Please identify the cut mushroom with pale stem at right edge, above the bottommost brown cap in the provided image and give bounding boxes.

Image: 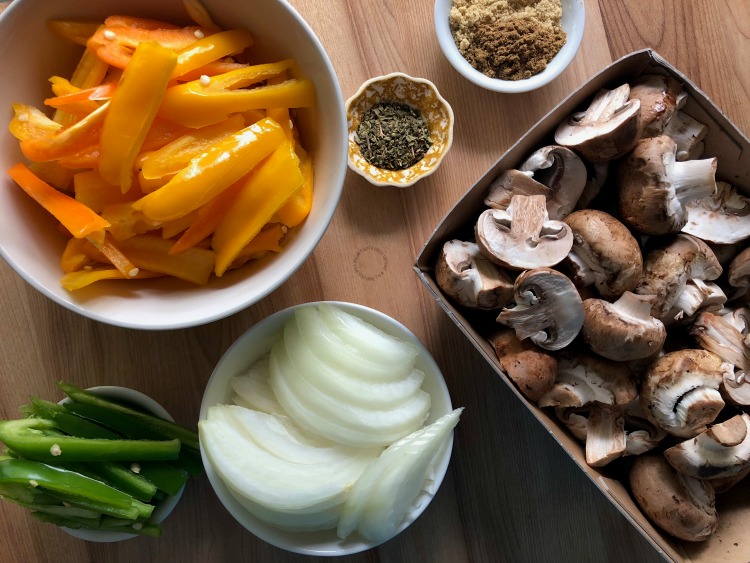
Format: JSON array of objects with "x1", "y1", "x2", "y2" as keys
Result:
[{"x1": 664, "y1": 414, "x2": 750, "y2": 479}]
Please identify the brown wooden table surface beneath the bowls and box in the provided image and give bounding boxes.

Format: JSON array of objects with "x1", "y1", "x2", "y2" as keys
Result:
[{"x1": 0, "y1": 0, "x2": 750, "y2": 563}]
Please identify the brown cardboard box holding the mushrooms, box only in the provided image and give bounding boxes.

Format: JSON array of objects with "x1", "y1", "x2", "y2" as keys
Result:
[{"x1": 415, "y1": 50, "x2": 750, "y2": 563}]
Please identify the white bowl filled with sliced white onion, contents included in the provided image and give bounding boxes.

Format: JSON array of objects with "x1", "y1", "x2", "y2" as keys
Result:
[{"x1": 199, "y1": 302, "x2": 461, "y2": 556}]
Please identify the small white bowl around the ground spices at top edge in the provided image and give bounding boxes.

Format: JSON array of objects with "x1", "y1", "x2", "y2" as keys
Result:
[{"x1": 434, "y1": 0, "x2": 586, "y2": 94}]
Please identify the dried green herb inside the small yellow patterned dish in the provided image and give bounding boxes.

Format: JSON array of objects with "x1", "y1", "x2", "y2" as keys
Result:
[{"x1": 354, "y1": 101, "x2": 432, "y2": 170}]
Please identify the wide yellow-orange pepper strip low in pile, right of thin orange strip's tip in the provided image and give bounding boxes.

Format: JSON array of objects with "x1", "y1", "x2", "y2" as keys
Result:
[{"x1": 118, "y1": 234, "x2": 215, "y2": 285}]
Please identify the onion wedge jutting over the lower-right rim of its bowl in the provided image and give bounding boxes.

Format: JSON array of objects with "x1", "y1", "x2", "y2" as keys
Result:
[{"x1": 337, "y1": 408, "x2": 463, "y2": 542}]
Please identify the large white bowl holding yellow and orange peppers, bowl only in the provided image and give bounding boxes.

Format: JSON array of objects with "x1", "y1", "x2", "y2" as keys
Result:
[{"x1": 0, "y1": 0, "x2": 347, "y2": 329}]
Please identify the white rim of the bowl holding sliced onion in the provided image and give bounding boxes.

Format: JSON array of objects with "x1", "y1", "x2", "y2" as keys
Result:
[{"x1": 199, "y1": 301, "x2": 454, "y2": 556}]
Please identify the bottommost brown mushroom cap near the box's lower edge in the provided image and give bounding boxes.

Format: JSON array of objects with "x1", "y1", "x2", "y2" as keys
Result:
[{"x1": 629, "y1": 454, "x2": 719, "y2": 541}]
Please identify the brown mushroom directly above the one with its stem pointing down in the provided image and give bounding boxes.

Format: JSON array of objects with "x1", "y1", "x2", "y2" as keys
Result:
[{"x1": 537, "y1": 354, "x2": 638, "y2": 408}]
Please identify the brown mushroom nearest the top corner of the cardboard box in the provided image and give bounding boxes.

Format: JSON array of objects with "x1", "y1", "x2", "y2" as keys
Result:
[{"x1": 630, "y1": 74, "x2": 684, "y2": 137}]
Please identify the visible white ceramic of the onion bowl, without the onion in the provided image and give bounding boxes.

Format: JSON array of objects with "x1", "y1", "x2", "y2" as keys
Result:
[{"x1": 200, "y1": 302, "x2": 453, "y2": 556}]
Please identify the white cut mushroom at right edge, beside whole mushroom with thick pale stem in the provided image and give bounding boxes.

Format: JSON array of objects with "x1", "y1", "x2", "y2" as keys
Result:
[{"x1": 681, "y1": 182, "x2": 750, "y2": 244}]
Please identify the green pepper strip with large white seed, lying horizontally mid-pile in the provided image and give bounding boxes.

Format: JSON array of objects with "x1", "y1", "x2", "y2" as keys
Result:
[{"x1": 0, "y1": 418, "x2": 180, "y2": 462}]
